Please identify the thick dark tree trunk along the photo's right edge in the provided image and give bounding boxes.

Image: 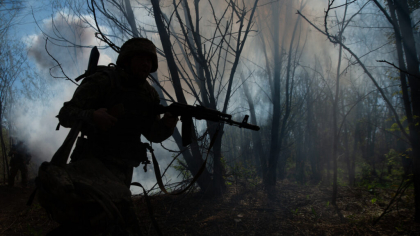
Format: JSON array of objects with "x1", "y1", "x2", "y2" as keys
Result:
[{"x1": 374, "y1": 0, "x2": 420, "y2": 222}]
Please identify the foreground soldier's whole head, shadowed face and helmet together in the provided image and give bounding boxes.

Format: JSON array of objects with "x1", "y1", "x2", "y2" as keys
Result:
[{"x1": 117, "y1": 38, "x2": 158, "y2": 81}]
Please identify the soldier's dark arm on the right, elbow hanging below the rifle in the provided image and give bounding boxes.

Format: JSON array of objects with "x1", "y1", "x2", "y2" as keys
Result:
[{"x1": 143, "y1": 88, "x2": 177, "y2": 143}]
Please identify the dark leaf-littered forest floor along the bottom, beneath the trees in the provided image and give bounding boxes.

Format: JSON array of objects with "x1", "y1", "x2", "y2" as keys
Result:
[{"x1": 0, "y1": 181, "x2": 420, "y2": 236}]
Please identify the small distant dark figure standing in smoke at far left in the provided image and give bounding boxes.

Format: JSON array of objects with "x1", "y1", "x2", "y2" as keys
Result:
[{"x1": 9, "y1": 141, "x2": 31, "y2": 187}]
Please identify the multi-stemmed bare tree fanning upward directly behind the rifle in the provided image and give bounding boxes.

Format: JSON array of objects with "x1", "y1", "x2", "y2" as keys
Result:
[{"x1": 152, "y1": 1, "x2": 258, "y2": 195}]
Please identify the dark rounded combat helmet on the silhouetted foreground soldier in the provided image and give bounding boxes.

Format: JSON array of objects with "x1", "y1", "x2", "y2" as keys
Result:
[{"x1": 117, "y1": 38, "x2": 158, "y2": 72}]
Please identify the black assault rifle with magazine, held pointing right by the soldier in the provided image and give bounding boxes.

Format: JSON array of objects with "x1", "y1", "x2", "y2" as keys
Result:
[{"x1": 155, "y1": 102, "x2": 260, "y2": 147}]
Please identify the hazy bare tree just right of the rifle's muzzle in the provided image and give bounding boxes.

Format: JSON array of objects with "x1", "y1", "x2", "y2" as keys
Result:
[{"x1": 254, "y1": 1, "x2": 305, "y2": 191}]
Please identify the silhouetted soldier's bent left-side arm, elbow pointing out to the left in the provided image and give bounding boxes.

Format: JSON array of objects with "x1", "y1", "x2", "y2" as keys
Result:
[{"x1": 57, "y1": 73, "x2": 111, "y2": 128}]
